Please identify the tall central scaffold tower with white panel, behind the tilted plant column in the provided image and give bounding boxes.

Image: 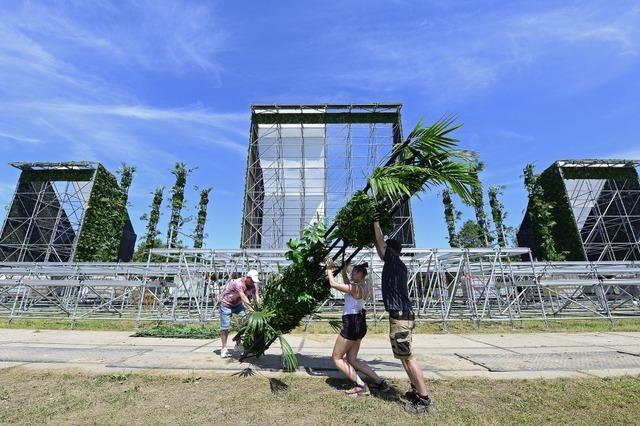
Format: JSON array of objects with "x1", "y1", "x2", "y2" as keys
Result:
[{"x1": 241, "y1": 104, "x2": 415, "y2": 249}]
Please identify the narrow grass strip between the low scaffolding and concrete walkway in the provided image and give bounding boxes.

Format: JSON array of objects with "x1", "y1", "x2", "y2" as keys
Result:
[{"x1": 0, "y1": 317, "x2": 640, "y2": 334}]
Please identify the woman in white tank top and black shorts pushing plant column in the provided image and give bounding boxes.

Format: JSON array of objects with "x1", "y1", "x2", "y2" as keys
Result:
[{"x1": 327, "y1": 259, "x2": 389, "y2": 396}]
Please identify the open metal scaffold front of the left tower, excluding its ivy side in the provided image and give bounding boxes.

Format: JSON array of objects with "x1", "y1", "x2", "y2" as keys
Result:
[{"x1": 0, "y1": 161, "x2": 98, "y2": 262}]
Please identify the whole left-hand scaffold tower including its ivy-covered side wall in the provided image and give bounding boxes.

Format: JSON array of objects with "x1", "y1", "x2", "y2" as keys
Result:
[{"x1": 0, "y1": 162, "x2": 136, "y2": 262}]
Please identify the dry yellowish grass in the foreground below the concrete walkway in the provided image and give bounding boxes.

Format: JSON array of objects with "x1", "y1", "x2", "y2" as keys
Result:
[{"x1": 0, "y1": 368, "x2": 640, "y2": 425}]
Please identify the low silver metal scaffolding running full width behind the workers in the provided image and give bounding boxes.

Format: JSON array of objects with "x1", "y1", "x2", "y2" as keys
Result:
[{"x1": 0, "y1": 248, "x2": 640, "y2": 327}]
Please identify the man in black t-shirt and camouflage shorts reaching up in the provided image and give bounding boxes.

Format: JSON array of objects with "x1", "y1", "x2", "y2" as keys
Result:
[{"x1": 373, "y1": 218, "x2": 431, "y2": 414}]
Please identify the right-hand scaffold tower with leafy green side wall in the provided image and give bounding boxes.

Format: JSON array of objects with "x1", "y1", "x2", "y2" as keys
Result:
[{"x1": 518, "y1": 160, "x2": 640, "y2": 261}]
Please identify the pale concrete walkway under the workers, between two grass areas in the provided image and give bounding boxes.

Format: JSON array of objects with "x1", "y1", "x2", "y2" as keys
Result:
[{"x1": 0, "y1": 329, "x2": 640, "y2": 379}]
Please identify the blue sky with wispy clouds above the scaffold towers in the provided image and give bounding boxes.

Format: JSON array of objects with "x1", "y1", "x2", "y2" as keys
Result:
[{"x1": 0, "y1": 0, "x2": 640, "y2": 248}]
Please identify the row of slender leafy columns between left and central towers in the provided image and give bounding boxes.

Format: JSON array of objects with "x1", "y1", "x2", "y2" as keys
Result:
[{"x1": 118, "y1": 163, "x2": 212, "y2": 262}]
